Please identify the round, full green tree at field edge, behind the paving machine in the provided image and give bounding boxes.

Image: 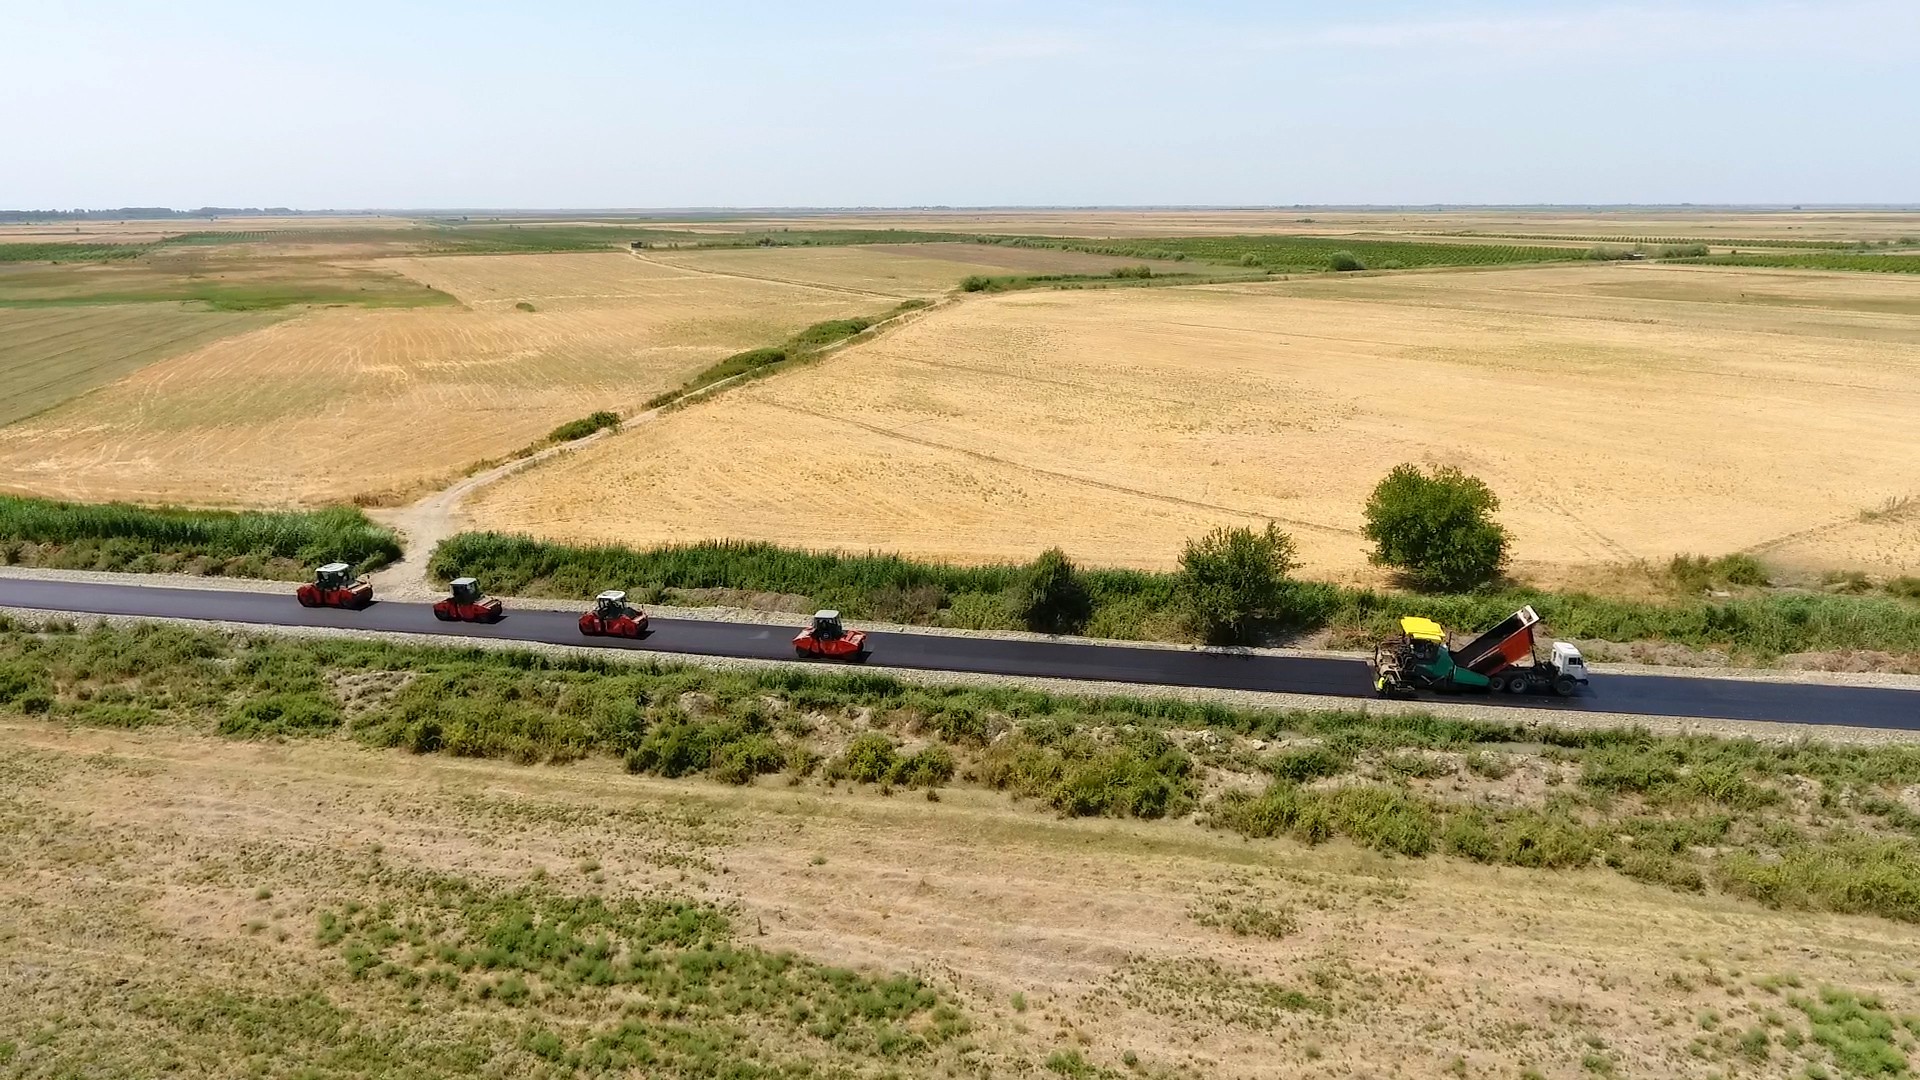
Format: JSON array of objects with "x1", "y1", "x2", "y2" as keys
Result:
[{"x1": 1361, "y1": 465, "x2": 1507, "y2": 590}]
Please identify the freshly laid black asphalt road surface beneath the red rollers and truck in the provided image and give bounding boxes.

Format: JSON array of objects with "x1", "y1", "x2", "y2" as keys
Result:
[{"x1": 0, "y1": 578, "x2": 1920, "y2": 730}]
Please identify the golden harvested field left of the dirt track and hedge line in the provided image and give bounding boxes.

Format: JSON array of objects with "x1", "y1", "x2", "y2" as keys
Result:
[{"x1": 0, "y1": 254, "x2": 889, "y2": 505}]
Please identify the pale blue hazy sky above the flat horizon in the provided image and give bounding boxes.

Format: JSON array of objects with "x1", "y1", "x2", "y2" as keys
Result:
[{"x1": 0, "y1": 0, "x2": 1920, "y2": 209}]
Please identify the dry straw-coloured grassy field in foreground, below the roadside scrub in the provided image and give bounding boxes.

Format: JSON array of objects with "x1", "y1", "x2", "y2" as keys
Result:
[{"x1": 11, "y1": 714, "x2": 1920, "y2": 1080}]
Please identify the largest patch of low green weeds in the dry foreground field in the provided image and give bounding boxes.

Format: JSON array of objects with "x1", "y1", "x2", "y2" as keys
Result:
[{"x1": 317, "y1": 876, "x2": 970, "y2": 1076}]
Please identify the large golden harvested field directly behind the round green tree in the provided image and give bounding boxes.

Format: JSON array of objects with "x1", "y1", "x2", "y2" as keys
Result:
[{"x1": 470, "y1": 263, "x2": 1920, "y2": 578}]
